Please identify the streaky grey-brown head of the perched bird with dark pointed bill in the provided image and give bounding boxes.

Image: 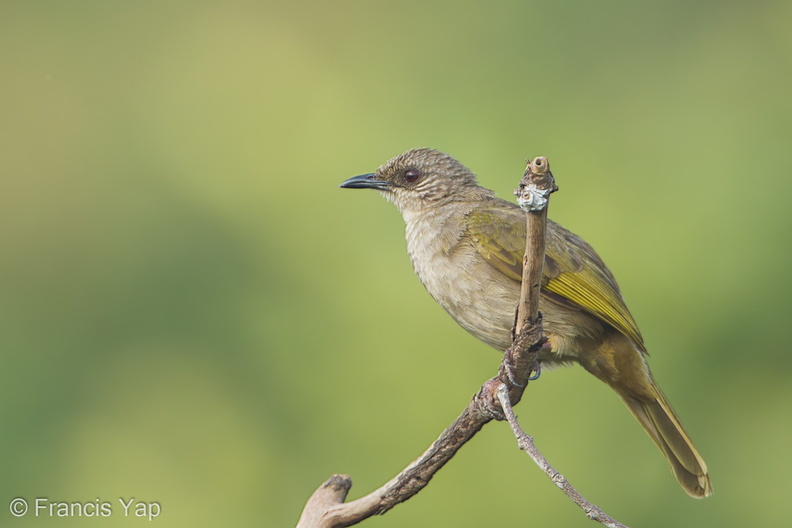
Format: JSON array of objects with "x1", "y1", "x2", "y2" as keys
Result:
[{"x1": 341, "y1": 148, "x2": 492, "y2": 214}]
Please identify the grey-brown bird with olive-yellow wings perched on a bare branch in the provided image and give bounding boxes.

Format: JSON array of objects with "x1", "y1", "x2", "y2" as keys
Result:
[{"x1": 341, "y1": 148, "x2": 713, "y2": 498}]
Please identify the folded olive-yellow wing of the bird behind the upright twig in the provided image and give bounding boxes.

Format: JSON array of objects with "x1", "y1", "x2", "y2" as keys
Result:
[{"x1": 466, "y1": 207, "x2": 644, "y2": 349}]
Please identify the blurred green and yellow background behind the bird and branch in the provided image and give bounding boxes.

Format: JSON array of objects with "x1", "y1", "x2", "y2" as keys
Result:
[{"x1": 0, "y1": 0, "x2": 792, "y2": 528}]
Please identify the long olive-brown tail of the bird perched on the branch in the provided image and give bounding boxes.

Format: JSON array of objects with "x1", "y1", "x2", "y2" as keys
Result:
[{"x1": 617, "y1": 382, "x2": 712, "y2": 499}]
